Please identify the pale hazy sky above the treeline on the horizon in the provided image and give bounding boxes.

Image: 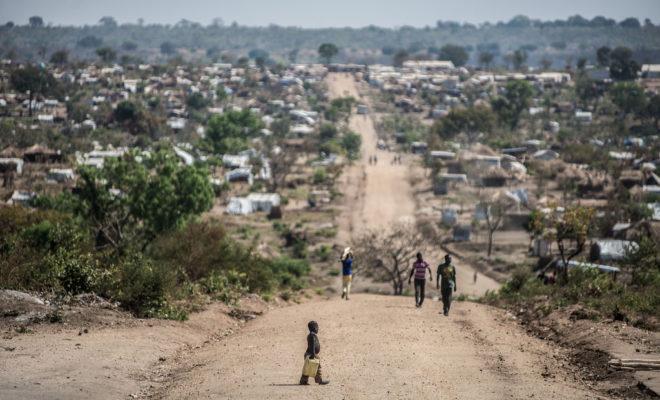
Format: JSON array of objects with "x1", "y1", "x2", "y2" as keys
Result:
[{"x1": 0, "y1": 0, "x2": 660, "y2": 27}]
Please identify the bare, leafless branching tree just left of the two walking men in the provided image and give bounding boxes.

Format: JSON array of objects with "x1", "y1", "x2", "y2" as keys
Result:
[{"x1": 355, "y1": 223, "x2": 429, "y2": 295}]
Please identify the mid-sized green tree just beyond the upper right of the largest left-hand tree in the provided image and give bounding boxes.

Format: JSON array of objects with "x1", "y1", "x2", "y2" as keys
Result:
[{"x1": 206, "y1": 110, "x2": 263, "y2": 154}]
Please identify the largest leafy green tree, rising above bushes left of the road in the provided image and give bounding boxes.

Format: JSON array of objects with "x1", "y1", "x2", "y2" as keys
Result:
[{"x1": 75, "y1": 150, "x2": 213, "y2": 250}]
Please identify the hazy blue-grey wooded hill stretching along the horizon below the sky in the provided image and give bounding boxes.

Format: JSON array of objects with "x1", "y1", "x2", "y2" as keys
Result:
[{"x1": 0, "y1": 16, "x2": 660, "y2": 67}]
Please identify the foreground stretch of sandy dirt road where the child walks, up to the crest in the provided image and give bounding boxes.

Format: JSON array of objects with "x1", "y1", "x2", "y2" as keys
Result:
[{"x1": 164, "y1": 295, "x2": 600, "y2": 400}]
